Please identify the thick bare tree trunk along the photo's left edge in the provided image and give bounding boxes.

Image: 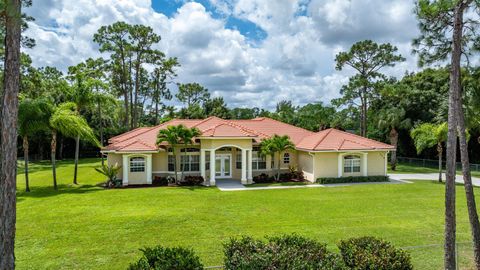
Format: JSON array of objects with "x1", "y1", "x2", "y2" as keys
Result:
[{"x1": 0, "y1": 0, "x2": 21, "y2": 270}]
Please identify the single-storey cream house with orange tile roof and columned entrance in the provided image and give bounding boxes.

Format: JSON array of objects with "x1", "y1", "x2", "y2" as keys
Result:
[{"x1": 102, "y1": 117, "x2": 394, "y2": 185}]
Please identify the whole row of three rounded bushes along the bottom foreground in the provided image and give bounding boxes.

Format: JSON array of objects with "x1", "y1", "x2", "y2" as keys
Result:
[{"x1": 129, "y1": 234, "x2": 413, "y2": 270}]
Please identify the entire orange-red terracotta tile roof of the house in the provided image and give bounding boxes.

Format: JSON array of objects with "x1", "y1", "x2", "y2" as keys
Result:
[{"x1": 102, "y1": 117, "x2": 394, "y2": 152}]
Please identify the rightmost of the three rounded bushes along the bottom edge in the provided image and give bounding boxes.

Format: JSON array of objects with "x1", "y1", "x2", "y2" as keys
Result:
[{"x1": 338, "y1": 237, "x2": 413, "y2": 270}]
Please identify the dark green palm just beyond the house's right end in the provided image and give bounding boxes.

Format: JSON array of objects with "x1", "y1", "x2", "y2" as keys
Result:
[{"x1": 378, "y1": 107, "x2": 412, "y2": 171}]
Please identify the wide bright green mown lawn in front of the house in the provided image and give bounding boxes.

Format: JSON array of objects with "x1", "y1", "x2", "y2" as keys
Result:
[{"x1": 16, "y1": 160, "x2": 480, "y2": 269}]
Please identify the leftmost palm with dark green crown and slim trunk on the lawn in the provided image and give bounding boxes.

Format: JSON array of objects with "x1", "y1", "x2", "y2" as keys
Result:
[{"x1": 18, "y1": 98, "x2": 49, "y2": 192}]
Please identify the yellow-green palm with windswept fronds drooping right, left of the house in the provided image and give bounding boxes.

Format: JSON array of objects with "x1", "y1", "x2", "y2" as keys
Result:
[{"x1": 49, "y1": 102, "x2": 100, "y2": 189}]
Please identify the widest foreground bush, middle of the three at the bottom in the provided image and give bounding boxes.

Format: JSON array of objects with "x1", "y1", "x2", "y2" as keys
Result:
[{"x1": 224, "y1": 235, "x2": 346, "y2": 270}]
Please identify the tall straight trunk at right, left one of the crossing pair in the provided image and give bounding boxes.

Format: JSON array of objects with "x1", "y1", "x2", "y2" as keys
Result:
[{"x1": 444, "y1": 4, "x2": 463, "y2": 270}]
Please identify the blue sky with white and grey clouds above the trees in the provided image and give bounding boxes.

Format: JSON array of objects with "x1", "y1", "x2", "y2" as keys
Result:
[{"x1": 26, "y1": 0, "x2": 418, "y2": 109}]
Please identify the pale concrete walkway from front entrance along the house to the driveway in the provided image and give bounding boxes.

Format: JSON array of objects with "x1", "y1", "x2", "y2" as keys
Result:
[{"x1": 216, "y1": 179, "x2": 411, "y2": 191}]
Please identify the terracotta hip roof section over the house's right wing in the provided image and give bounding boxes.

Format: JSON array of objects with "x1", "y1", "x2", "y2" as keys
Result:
[{"x1": 296, "y1": 128, "x2": 395, "y2": 151}]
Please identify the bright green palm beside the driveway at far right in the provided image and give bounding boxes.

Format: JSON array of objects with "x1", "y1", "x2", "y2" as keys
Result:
[{"x1": 410, "y1": 123, "x2": 448, "y2": 182}]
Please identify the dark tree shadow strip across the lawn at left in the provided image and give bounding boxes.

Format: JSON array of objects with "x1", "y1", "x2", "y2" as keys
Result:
[{"x1": 17, "y1": 184, "x2": 105, "y2": 201}]
